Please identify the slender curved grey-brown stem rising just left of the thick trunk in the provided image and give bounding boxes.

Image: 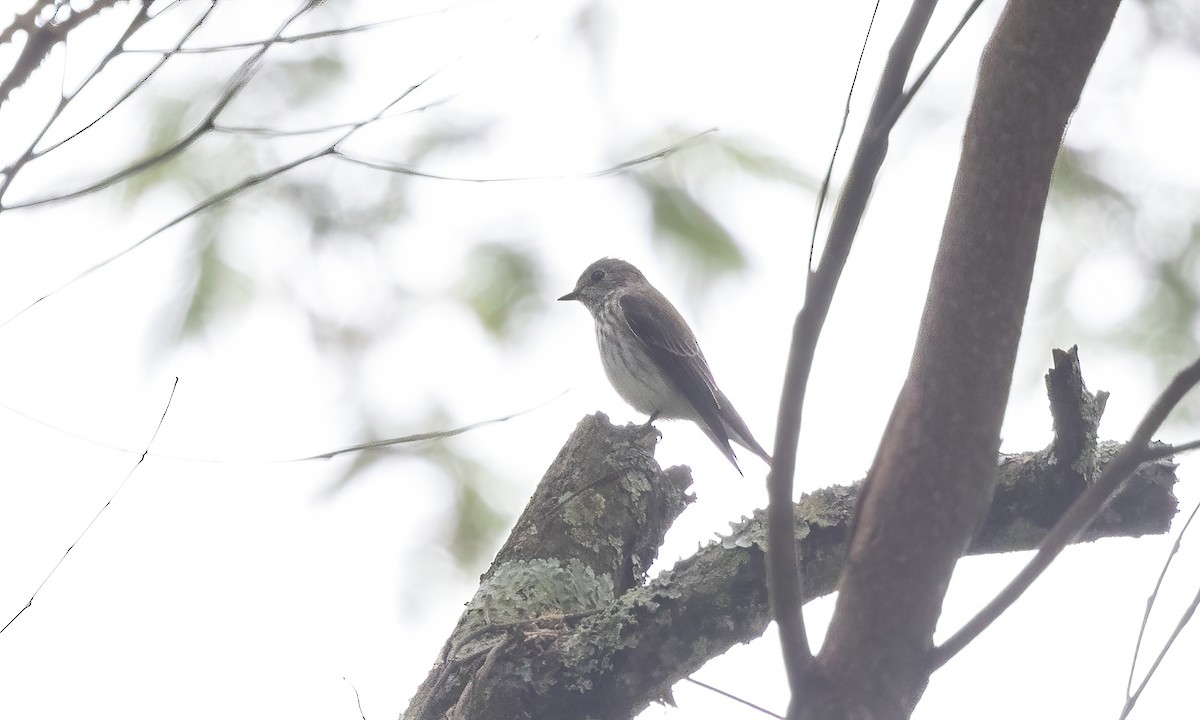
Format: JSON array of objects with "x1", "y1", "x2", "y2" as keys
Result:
[{"x1": 767, "y1": 0, "x2": 936, "y2": 700}]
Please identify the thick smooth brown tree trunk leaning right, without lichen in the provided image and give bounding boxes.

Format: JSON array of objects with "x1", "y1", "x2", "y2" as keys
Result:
[{"x1": 816, "y1": 0, "x2": 1117, "y2": 719}]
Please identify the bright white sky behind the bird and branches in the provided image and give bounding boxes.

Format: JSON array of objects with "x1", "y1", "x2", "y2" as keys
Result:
[{"x1": 0, "y1": 0, "x2": 1200, "y2": 720}]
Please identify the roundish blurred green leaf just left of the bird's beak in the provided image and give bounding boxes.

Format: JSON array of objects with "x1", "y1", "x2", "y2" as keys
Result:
[{"x1": 458, "y1": 242, "x2": 541, "y2": 338}]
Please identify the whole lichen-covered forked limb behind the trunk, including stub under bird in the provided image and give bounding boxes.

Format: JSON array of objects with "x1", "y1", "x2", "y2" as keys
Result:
[{"x1": 404, "y1": 352, "x2": 1176, "y2": 719}]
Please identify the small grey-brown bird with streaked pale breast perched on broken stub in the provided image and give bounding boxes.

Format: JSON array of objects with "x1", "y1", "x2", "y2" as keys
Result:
[{"x1": 559, "y1": 258, "x2": 770, "y2": 474}]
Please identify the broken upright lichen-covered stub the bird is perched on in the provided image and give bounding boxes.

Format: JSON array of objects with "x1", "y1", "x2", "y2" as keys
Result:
[{"x1": 404, "y1": 414, "x2": 692, "y2": 719}]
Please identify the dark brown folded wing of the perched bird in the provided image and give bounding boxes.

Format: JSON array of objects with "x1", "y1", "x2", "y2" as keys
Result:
[{"x1": 619, "y1": 293, "x2": 737, "y2": 467}]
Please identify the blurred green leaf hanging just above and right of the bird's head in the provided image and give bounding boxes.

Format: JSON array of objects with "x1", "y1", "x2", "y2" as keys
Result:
[{"x1": 638, "y1": 176, "x2": 745, "y2": 274}]
